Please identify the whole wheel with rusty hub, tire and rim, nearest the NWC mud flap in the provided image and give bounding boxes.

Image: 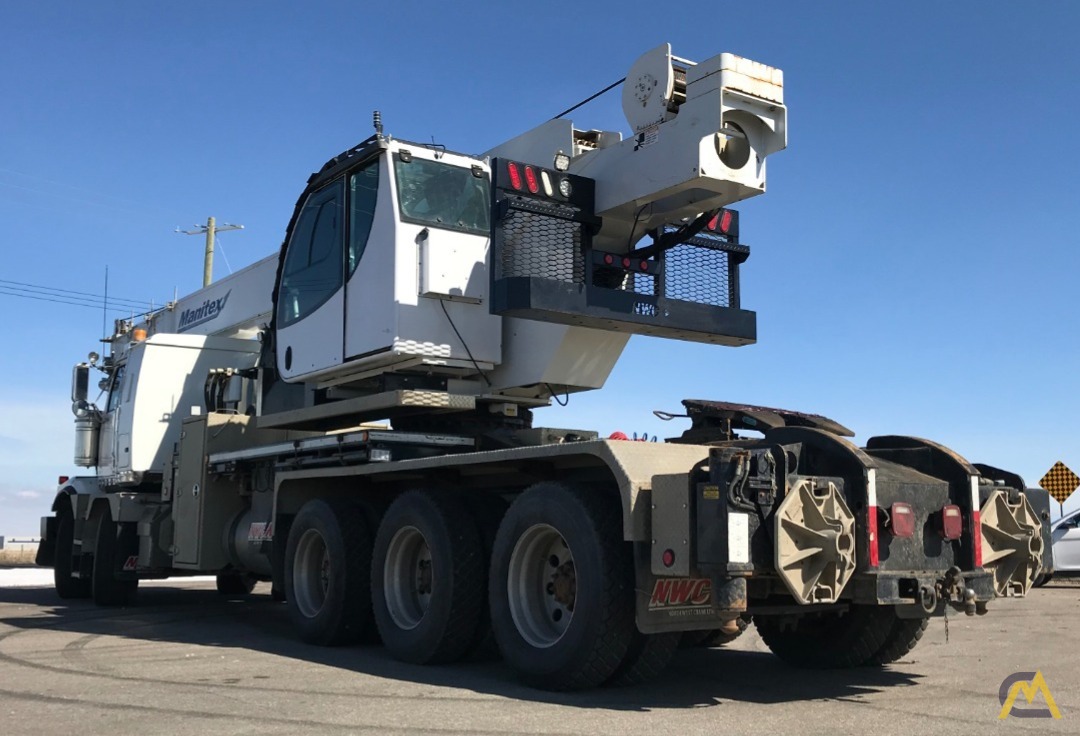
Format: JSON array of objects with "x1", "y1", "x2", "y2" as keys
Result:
[{"x1": 490, "y1": 482, "x2": 635, "y2": 691}]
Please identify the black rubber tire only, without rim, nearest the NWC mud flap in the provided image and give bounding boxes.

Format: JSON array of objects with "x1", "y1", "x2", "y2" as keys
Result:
[{"x1": 489, "y1": 482, "x2": 636, "y2": 691}]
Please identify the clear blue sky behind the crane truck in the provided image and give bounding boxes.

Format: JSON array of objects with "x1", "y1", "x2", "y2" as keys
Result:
[{"x1": 0, "y1": 1, "x2": 1080, "y2": 534}]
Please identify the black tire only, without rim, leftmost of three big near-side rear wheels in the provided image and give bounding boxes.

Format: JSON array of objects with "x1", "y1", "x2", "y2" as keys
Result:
[{"x1": 284, "y1": 498, "x2": 372, "y2": 646}]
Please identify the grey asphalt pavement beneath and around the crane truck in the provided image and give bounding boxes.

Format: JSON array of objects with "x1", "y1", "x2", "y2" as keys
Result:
[{"x1": 0, "y1": 571, "x2": 1080, "y2": 736}]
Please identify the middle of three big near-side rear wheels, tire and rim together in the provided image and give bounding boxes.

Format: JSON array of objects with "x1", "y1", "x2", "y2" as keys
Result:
[{"x1": 372, "y1": 491, "x2": 487, "y2": 665}]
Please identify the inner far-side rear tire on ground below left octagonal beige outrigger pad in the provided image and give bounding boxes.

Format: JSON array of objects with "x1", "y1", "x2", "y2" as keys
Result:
[{"x1": 754, "y1": 605, "x2": 896, "y2": 669}]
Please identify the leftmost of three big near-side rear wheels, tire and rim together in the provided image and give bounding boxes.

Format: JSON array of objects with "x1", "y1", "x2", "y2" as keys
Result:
[{"x1": 285, "y1": 498, "x2": 372, "y2": 646}]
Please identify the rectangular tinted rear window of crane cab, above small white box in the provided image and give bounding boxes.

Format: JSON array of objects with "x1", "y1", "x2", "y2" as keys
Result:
[{"x1": 394, "y1": 155, "x2": 490, "y2": 236}]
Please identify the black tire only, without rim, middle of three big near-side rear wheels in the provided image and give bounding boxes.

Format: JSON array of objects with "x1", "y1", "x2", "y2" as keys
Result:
[{"x1": 372, "y1": 491, "x2": 487, "y2": 665}]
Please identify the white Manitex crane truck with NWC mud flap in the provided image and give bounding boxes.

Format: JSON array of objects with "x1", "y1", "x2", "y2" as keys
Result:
[{"x1": 31, "y1": 44, "x2": 1045, "y2": 690}]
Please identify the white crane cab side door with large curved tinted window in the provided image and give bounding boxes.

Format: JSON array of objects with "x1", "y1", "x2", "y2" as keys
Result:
[{"x1": 276, "y1": 179, "x2": 345, "y2": 380}]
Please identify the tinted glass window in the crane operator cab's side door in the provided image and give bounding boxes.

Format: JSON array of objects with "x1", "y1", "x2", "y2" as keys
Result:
[{"x1": 278, "y1": 179, "x2": 345, "y2": 326}]
